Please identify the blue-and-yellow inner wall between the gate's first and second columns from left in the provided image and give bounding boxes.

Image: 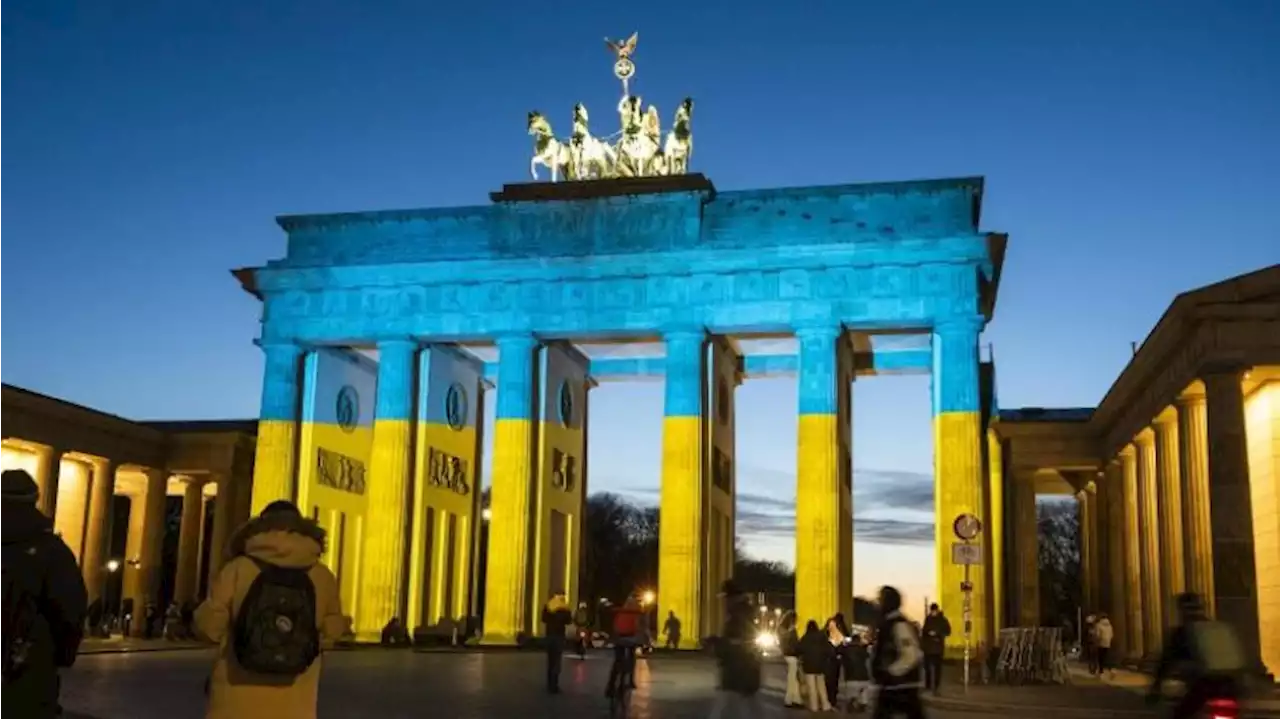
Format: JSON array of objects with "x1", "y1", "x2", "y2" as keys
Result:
[{"x1": 297, "y1": 348, "x2": 378, "y2": 617}]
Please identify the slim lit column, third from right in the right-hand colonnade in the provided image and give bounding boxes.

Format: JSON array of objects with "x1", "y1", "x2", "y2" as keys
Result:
[{"x1": 1155, "y1": 411, "x2": 1187, "y2": 636}]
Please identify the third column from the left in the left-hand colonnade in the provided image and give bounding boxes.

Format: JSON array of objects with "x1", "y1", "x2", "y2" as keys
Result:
[{"x1": 125, "y1": 468, "x2": 169, "y2": 636}]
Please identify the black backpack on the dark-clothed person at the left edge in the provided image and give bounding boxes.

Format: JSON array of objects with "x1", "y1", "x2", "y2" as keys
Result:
[{"x1": 0, "y1": 542, "x2": 42, "y2": 687}]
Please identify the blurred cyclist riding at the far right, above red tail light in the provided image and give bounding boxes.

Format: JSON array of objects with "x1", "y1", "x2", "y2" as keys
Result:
[{"x1": 1147, "y1": 592, "x2": 1248, "y2": 719}]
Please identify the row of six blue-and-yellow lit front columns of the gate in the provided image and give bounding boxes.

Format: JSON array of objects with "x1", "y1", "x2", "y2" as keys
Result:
[{"x1": 252, "y1": 317, "x2": 992, "y2": 646}]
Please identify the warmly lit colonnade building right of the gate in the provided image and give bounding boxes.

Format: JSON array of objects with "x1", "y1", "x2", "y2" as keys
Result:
[{"x1": 989, "y1": 265, "x2": 1280, "y2": 672}]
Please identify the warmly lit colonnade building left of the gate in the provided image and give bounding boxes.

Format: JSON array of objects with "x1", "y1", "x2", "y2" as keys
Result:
[{"x1": 0, "y1": 384, "x2": 257, "y2": 628}]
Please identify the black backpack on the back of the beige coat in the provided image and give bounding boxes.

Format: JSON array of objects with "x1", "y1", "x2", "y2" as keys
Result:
[{"x1": 233, "y1": 558, "x2": 320, "y2": 677}]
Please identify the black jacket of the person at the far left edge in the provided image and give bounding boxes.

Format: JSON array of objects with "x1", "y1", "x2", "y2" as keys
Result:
[{"x1": 0, "y1": 500, "x2": 88, "y2": 719}]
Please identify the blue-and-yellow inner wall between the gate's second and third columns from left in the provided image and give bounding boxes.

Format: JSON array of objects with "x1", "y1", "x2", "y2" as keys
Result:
[{"x1": 408, "y1": 345, "x2": 484, "y2": 627}]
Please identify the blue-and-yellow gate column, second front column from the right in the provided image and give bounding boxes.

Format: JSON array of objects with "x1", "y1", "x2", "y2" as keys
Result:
[{"x1": 796, "y1": 326, "x2": 852, "y2": 622}]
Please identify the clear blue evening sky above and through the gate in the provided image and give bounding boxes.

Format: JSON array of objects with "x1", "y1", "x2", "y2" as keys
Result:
[{"x1": 0, "y1": 0, "x2": 1280, "y2": 585}]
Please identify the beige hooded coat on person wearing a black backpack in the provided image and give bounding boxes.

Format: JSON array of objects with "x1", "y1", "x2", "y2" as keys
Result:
[{"x1": 196, "y1": 517, "x2": 348, "y2": 719}]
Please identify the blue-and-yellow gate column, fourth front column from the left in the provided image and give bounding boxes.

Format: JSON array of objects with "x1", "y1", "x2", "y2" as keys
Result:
[{"x1": 658, "y1": 330, "x2": 706, "y2": 649}]
